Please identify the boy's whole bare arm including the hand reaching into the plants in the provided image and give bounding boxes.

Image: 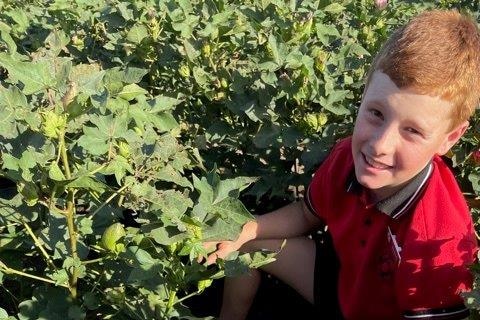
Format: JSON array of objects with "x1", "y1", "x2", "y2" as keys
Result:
[{"x1": 205, "y1": 200, "x2": 322, "y2": 264}]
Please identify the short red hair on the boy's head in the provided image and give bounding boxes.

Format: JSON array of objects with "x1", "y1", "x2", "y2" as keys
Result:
[{"x1": 367, "y1": 10, "x2": 480, "y2": 127}]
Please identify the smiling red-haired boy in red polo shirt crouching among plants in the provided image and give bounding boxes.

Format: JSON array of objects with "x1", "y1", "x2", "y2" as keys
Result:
[{"x1": 202, "y1": 11, "x2": 480, "y2": 320}]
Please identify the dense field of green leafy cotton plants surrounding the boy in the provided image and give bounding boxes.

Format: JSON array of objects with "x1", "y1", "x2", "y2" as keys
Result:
[{"x1": 0, "y1": 0, "x2": 480, "y2": 320}]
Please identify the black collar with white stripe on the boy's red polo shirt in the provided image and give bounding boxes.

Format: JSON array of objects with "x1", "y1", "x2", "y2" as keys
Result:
[{"x1": 346, "y1": 162, "x2": 433, "y2": 219}]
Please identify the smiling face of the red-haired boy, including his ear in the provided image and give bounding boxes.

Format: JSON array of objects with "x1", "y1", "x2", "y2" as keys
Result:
[{"x1": 352, "y1": 71, "x2": 468, "y2": 200}]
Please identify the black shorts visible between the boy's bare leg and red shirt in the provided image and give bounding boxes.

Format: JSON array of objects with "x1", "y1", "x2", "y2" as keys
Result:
[{"x1": 313, "y1": 231, "x2": 343, "y2": 320}]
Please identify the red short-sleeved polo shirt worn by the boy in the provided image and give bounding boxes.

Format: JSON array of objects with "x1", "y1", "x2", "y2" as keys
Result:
[{"x1": 306, "y1": 138, "x2": 477, "y2": 320}]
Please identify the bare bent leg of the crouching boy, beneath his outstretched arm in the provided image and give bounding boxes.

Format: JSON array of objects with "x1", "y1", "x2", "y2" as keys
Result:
[{"x1": 220, "y1": 237, "x2": 315, "y2": 320}]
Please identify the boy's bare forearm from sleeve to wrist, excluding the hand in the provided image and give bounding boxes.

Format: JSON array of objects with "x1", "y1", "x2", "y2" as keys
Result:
[{"x1": 239, "y1": 201, "x2": 321, "y2": 242}]
